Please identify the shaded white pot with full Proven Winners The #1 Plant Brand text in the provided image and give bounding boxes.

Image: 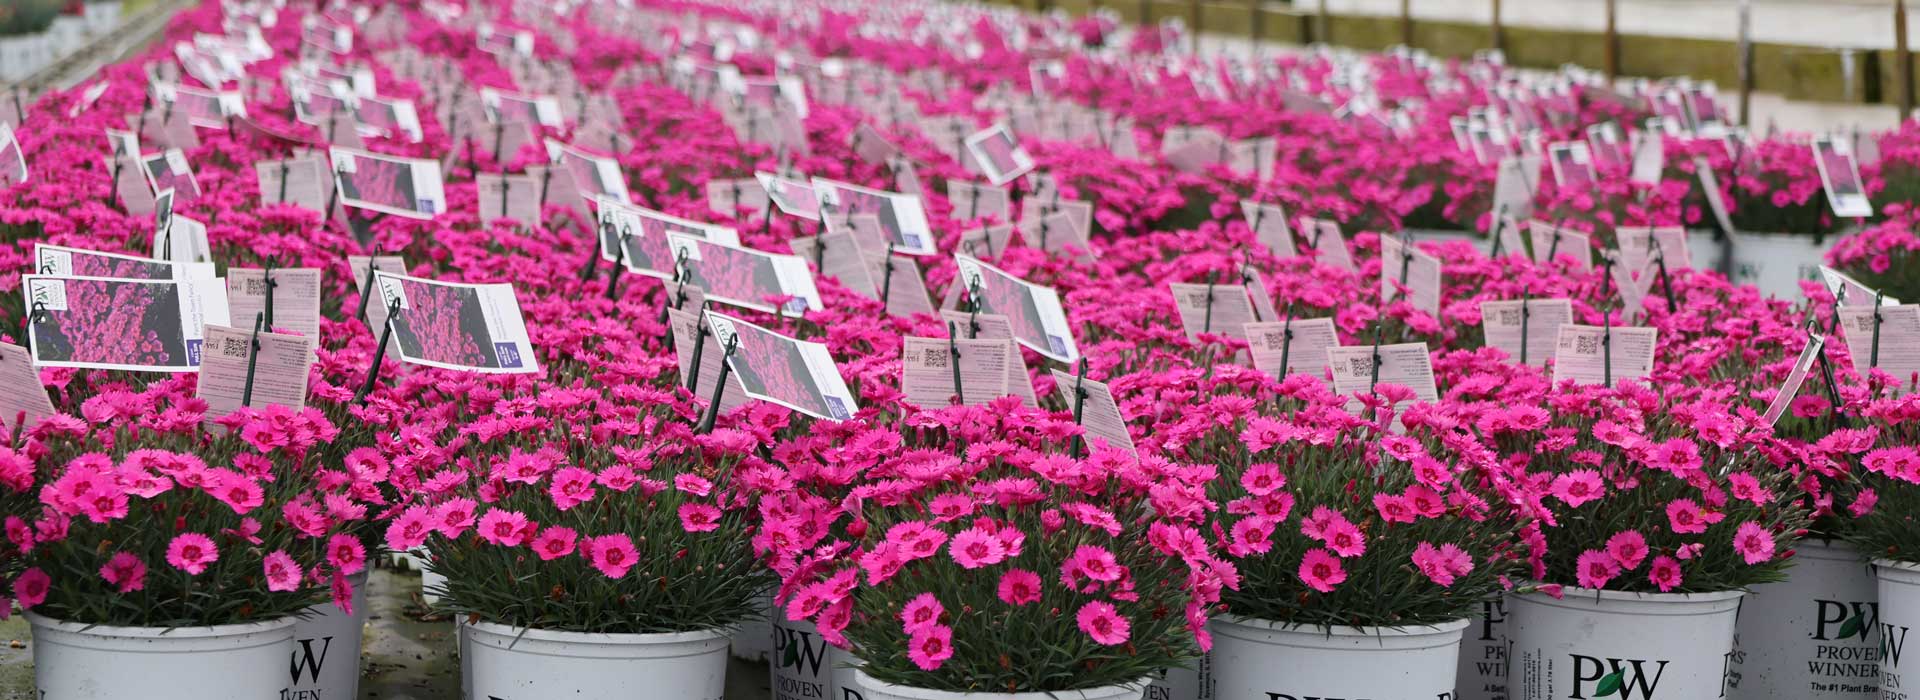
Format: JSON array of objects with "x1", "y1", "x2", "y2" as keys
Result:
[{"x1": 1726, "y1": 539, "x2": 1880, "y2": 700}]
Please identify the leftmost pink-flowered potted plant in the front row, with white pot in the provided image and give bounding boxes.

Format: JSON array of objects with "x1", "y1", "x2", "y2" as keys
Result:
[{"x1": 19, "y1": 393, "x2": 367, "y2": 700}]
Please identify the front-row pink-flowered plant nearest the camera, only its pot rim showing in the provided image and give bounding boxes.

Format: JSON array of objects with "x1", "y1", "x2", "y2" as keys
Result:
[{"x1": 764, "y1": 399, "x2": 1235, "y2": 700}]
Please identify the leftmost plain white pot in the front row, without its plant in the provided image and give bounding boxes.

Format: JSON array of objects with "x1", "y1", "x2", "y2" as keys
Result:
[{"x1": 27, "y1": 612, "x2": 294, "y2": 700}]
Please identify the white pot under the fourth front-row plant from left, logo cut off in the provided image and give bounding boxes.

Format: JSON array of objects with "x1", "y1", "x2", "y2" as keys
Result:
[{"x1": 1210, "y1": 616, "x2": 1467, "y2": 700}]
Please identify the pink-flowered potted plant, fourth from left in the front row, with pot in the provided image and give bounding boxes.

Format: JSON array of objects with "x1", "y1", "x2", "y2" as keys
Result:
[{"x1": 1183, "y1": 376, "x2": 1524, "y2": 698}]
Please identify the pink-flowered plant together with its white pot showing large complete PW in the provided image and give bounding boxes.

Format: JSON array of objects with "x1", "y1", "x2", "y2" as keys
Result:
[{"x1": 1490, "y1": 384, "x2": 1809, "y2": 700}]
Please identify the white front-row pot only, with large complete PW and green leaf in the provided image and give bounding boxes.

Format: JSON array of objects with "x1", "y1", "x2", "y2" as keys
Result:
[{"x1": 1507, "y1": 587, "x2": 1743, "y2": 700}]
